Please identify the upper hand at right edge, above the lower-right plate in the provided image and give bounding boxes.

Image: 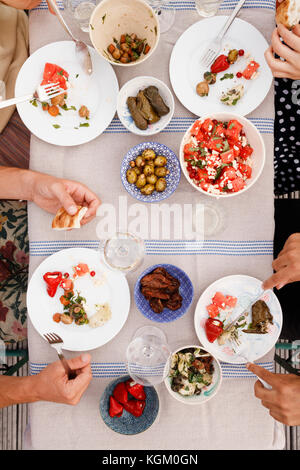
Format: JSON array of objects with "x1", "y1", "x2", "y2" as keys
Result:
[{"x1": 263, "y1": 233, "x2": 300, "y2": 290}]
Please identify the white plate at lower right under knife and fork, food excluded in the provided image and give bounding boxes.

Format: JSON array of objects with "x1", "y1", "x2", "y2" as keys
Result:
[{"x1": 194, "y1": 274, "x2": 282, "y2": 364}]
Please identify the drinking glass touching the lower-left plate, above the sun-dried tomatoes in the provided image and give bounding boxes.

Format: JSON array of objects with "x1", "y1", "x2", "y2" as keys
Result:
[{"x1": 102, "y1": 232, "x2": 145, "y2": 273}]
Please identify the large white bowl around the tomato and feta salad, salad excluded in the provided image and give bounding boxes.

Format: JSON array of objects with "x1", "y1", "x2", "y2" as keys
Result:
[{"x1": 179, "y1": 113, "x2": 266, "y2": 199}]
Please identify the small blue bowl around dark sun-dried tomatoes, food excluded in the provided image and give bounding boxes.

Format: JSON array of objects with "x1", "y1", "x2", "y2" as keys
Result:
[{"x1": 134, "y1": 264, "x2": 194, "y2": 323}]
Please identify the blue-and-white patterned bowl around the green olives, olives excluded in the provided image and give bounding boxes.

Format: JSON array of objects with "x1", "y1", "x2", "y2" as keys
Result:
[{"x1": 121, "y1": 142, "x2": 181, "y2": 202}]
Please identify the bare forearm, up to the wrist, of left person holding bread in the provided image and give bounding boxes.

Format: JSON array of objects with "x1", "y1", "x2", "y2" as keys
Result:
[{"x1": 0, "y1": 166, "x2": 36, "y2": 201}]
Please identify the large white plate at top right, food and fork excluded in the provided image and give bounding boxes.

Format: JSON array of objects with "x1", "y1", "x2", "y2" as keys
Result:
[{"x1": 170, "y1": 16, "x2": 273, "y2": 116}]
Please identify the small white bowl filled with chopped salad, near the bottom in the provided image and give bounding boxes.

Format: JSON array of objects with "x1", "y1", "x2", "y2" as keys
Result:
[{"x1": 165, "y1": 345, "x2": 222, "y2": 405}]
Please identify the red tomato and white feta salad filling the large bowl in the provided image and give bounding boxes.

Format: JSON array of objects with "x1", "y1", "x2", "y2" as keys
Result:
[{"x1": 183, "y1": 118, "x2": 253, "y2": 195}]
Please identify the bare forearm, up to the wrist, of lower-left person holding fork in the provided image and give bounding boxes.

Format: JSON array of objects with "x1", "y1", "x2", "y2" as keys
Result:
[{"x1": 0, "y1": 375, "x2": 38, "y2": 408}]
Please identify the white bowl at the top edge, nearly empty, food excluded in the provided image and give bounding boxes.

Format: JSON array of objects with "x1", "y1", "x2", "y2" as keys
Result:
[{"x1": 89, "y1": 0, "x2": 160, "y2": 67}]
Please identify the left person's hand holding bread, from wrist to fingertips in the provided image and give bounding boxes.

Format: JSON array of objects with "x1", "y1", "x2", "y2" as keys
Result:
[{"x1": 30, "y1": 172, "x2": 100, "y2": 225}]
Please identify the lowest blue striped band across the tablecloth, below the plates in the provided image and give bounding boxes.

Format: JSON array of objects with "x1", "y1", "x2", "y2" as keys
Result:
[{"x1": 29, "y1": 362, "x2": 274, "y2": 379}]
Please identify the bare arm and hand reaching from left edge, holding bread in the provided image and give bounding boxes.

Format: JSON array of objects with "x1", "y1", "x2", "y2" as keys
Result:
[{"x1": 0, "y1": 167, "x2": 100, "y2": 225}]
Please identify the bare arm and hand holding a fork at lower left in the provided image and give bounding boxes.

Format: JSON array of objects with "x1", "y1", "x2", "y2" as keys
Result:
[{"x1": 0, "y1": 354, "x2": 92, "y2": 408}]
